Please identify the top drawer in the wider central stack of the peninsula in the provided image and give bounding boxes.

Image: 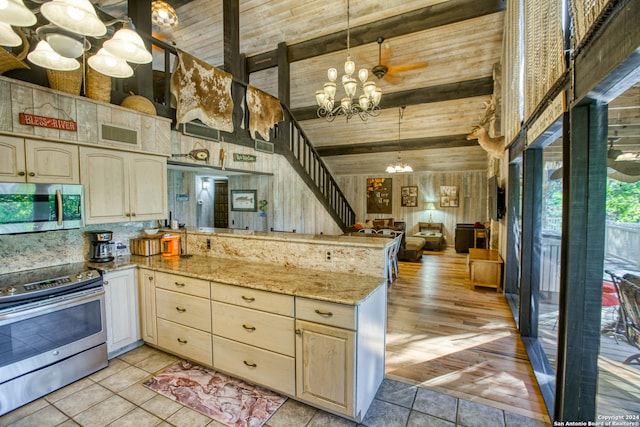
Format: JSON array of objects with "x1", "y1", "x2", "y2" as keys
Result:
[{"x1": 211, "y1": 282, "x2": 293, "y2": 317}]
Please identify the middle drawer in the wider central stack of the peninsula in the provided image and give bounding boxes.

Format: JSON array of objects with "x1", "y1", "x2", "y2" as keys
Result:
[{"x1": 211, "y1": 301, "x2": 295, "y2": 356}]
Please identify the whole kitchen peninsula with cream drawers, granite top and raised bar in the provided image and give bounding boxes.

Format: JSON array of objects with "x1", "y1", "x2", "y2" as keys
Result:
[{"x1": 96, "y1": 229, "x2": 391, "y2": 421}]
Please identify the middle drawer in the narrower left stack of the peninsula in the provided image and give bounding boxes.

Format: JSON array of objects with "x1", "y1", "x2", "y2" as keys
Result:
[{"x1": 156, "y1": 289, "x2": 211, "y2": 332}]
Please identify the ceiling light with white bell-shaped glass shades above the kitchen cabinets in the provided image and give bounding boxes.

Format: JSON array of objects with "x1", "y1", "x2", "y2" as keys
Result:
[{"x1": 0, "y1": 0, "x2": 160, "y2": 78}]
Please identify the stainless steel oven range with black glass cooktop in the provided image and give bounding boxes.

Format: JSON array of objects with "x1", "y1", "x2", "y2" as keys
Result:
[{"x1": 0, "y1": 263, "x2": 107, "y2": 415}]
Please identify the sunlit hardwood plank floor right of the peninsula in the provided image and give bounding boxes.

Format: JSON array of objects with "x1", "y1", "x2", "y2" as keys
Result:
[{"x1": 386, "y1": 248, "x2": 550, "y2": 422}]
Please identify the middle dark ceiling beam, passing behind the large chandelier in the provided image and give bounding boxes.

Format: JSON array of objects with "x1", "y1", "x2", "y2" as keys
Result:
[{"x1": 291, "y1": 77, "x2": 493, "y2": 121}]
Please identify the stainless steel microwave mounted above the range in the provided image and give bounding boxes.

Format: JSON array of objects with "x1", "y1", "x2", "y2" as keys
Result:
[{"x1": 0, "y1": 182, "x2": 84, "y2": 234}]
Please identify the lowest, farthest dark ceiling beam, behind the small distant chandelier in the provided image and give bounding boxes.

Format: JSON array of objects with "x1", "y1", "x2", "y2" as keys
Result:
[{"x1": 315, "y1": 135, "x2": 478, "y2": 157}]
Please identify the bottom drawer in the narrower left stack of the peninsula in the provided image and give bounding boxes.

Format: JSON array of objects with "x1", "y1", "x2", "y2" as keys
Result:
[{"x1": 158, "y1": 319, "x2": 212, "y2": 366}]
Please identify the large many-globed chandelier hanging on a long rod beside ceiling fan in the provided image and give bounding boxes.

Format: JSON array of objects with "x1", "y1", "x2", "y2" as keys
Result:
[{"x1": 316, "y1": 0, "x2": 382, "y2": 122}]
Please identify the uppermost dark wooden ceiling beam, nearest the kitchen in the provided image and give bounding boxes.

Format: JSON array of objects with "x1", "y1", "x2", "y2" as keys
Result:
[{"x1": 247, "y1": 0, "x2": 506, "y2": 73}]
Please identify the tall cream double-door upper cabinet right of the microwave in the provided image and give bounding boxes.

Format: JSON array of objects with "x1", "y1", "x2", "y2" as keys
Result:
[{"x1": 80, "y1": 147, "x2": 167, "y2": 224}]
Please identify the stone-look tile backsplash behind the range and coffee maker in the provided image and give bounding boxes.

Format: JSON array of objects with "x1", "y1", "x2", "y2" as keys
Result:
[{"x1": 0, "y1": 222, "x2": 150, "y2": 274}]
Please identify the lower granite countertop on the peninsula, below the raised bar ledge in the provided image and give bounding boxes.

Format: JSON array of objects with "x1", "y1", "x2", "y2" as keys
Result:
[{"x1": 90, "y1": 255, "x2": 386, "y2": 305}]
